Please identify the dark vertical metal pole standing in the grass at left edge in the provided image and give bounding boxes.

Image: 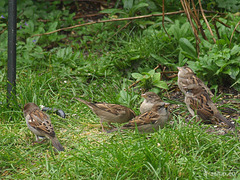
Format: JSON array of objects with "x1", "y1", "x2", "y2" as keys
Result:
[{"x1": 7, "y1": 0, "x2": 17, "y2": 104}]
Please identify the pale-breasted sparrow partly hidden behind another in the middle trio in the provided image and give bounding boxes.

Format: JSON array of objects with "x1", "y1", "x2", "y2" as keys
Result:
[{"x1": 140, "y1": 92, "x2": 162, "y2": 114}]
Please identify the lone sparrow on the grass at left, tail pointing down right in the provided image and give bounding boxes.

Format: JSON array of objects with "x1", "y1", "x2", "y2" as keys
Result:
[{"x1": 23, "y1": 103, "x2": 64, "y2": 151}]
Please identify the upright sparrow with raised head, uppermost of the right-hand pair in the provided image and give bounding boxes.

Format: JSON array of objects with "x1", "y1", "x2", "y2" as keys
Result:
[{"x1": 177, "y1": 66, "x2": 214, "y2": 97}]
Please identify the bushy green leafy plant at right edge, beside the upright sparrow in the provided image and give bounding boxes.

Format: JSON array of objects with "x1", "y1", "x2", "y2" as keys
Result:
[{"x1": 188, "y1": 44, "x2": 240, "y2": 90}]
